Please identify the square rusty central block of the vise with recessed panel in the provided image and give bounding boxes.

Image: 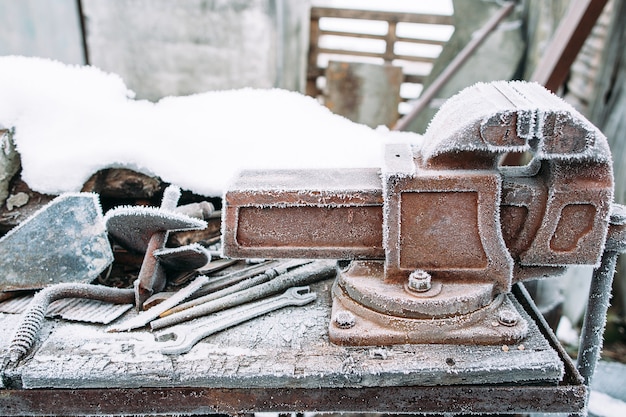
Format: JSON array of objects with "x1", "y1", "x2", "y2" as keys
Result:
[{"x1": 384, "y1": 153, "x2": 513, "y2": 292}]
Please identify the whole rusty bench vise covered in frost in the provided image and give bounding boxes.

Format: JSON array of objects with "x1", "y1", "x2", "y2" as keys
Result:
[{"x1": 223, "y1": 82, "x2": 613, "y2": 345}]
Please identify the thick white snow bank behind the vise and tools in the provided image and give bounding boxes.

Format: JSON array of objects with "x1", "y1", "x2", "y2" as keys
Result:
[{"x1": 0, "y1": 56, "x2": 419, "y2": 196}]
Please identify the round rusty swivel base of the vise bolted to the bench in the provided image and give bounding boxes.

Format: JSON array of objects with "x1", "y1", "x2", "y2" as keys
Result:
[{"x1": 329, "y1": 261, "x2": 529, "y2": 345}]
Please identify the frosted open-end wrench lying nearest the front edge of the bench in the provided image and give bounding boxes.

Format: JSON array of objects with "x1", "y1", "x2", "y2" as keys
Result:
[{"x1": 156, "y1": 286, "x2": 317, "y2": 355}]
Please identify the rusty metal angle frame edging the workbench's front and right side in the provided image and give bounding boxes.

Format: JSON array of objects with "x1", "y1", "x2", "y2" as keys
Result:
[{"x1": 0, "y1": 286, "x2": 586, "y2": 416}]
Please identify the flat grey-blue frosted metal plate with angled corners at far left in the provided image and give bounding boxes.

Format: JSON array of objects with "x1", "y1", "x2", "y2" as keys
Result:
[{"x1": 0, "y1": 193, "x2": 113, "y2": 291}]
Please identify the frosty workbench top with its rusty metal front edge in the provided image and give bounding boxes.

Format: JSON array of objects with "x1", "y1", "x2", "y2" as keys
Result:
[{"x1": 0, "y1": 280, "x2": 586, "y2": 416}]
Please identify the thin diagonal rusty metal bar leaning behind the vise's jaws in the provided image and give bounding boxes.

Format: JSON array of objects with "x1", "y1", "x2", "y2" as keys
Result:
[{"x1": 393, "y1": 1, "x2": 515, "y2": 130}]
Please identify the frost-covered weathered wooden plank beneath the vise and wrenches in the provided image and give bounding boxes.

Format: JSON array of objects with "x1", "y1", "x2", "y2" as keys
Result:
[{"x1": 6, "y1": 281, "x2": 563, "y2": 389}]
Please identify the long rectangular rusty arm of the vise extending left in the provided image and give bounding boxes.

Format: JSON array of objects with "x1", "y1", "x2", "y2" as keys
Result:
[{"x1": 223, "y1": 169, "x2": 384, "y2": 259}]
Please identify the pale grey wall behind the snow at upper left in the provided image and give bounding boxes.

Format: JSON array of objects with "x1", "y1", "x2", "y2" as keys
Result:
[{"x1": 0, "y1": 0, "x2": 310, "y2": 100}]
